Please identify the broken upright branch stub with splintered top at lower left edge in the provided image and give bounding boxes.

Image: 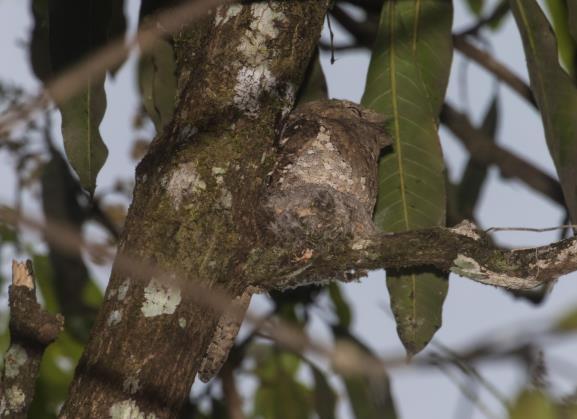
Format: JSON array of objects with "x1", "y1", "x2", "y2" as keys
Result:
[{"x1": 0, "y1": 261, "x2": 64, "y2": 419}]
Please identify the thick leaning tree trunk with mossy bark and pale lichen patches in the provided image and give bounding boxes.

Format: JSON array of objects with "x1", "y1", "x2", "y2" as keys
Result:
[{"x1": 61, "y1": 0, "x2": 327, "y2": 418}]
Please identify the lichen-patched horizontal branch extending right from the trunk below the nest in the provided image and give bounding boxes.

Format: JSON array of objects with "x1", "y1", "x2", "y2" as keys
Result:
[{"x1": 272, "y1": 221, "x2": 577, "y2": 290}]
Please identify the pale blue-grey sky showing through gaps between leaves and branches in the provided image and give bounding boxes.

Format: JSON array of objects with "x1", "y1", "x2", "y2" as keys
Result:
[{"x1": 0, "y1": 0, "x2": 577, "y2": 419}]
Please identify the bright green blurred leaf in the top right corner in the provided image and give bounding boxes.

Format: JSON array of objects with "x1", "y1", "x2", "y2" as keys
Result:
[{"x1": 546, "y1": 0, "x2": 577, "y2": 75}]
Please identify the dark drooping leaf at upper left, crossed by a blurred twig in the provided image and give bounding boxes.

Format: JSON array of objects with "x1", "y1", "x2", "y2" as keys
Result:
[{"x1": 49, "y1": 0, "x2": 126, "y2": 194}]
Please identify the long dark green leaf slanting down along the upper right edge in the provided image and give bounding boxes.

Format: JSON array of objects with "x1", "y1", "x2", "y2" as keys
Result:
[{"x1": 511, "y1": 0, "x2": 577, "y2": 223}]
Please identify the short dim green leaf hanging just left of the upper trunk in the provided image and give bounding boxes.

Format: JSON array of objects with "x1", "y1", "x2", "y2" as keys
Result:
[{"x1": 138, "y1": 39, "x2": 176, "y2": 133}]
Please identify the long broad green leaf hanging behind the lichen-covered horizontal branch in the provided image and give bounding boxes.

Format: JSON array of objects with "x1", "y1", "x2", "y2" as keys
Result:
[{"x1": 363, "y1": 0, "x2": 452, "y2": 355}]
